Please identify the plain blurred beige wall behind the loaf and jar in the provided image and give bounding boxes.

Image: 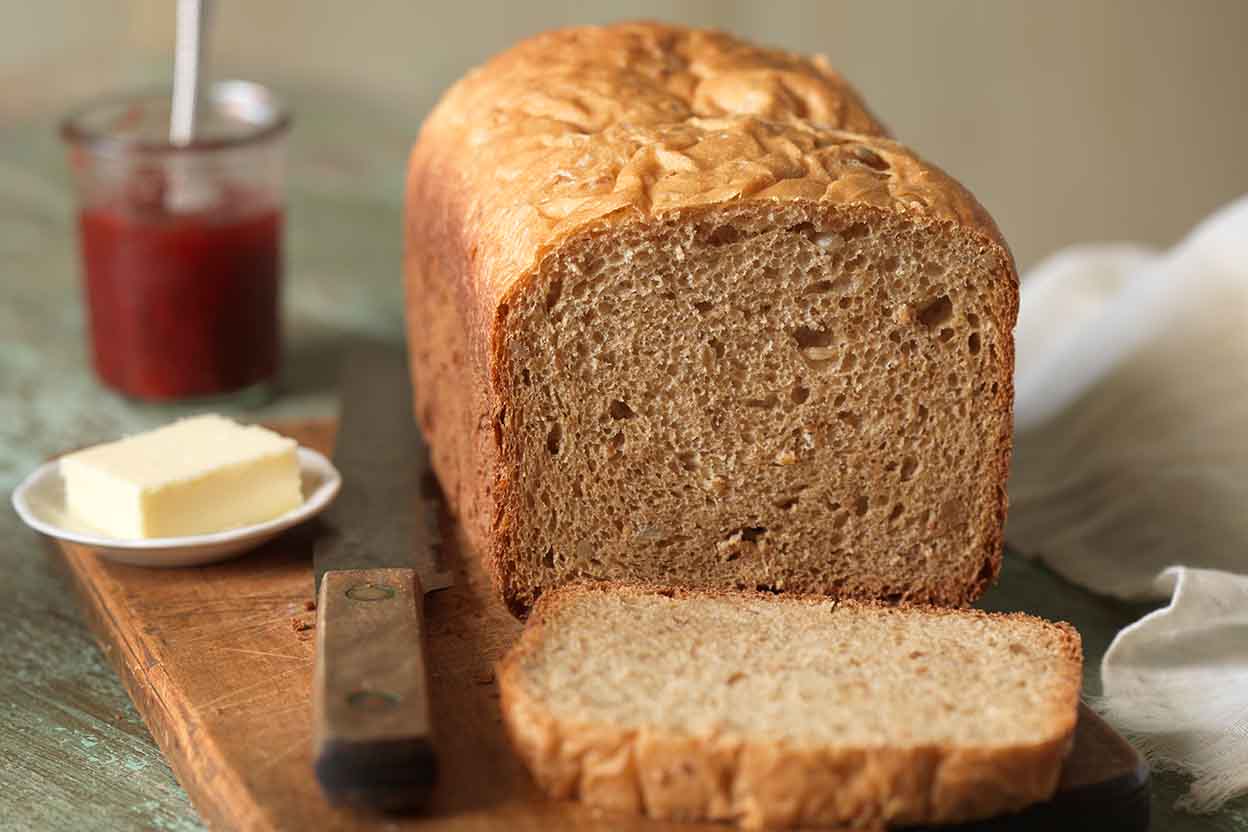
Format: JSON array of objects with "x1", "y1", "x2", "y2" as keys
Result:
[{"x1": 0, "y1": 0, "x2": 1248, "y2": 266}]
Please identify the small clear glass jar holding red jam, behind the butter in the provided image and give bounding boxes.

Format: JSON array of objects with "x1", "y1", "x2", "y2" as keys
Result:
[{"x1": 61, "y1": 81, "x2": 290, "y2": 402}]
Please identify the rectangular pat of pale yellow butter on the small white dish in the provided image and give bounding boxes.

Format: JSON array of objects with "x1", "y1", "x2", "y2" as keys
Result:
[{"x1": 60, "y1": 415, "x2": 303, "y2": 539}]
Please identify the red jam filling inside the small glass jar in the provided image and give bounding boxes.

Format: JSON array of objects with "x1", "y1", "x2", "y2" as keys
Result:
[{"x1": 79, "y1": 188, "x2": 282, "y2": 400}]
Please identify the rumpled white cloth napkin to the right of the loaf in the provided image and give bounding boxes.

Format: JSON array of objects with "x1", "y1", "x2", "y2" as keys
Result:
[{"x1": 1006, "y1": 197, "x2": 1248, "y2": 811}]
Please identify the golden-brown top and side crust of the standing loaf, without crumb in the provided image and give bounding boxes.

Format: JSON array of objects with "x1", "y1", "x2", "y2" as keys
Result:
[{"x1": 404, "y1": 24, "x2": 1017, "y2": 614}]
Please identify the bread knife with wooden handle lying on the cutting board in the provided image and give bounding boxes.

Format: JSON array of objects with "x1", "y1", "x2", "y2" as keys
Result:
[{"x1": 312, "y1": 346, "x2": 453, "y2": 811}]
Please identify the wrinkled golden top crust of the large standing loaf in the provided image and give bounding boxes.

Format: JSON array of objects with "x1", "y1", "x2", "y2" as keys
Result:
[{"x1": 409, "y1": 22, "x2": 1008, "y2": 321}]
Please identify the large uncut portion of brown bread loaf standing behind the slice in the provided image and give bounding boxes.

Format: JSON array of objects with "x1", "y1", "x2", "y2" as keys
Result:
[{"x1": 404, "y1": 24, "x2": 1017, "y2": 615}]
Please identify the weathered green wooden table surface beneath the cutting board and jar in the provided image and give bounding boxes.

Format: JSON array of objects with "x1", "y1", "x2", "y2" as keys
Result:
[{"x1": 0, "y1": 79, "x2": 1248, "y2": 832}]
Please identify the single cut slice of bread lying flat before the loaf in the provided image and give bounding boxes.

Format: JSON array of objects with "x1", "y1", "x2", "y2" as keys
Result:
[{"x1": 499, "y1": 584, "x2": 1082, "y2": 828}]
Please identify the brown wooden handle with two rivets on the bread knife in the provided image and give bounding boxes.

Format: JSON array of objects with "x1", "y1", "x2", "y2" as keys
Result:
[{"x1": 312, "y1": 569, "x2": 438, "y2": 812}]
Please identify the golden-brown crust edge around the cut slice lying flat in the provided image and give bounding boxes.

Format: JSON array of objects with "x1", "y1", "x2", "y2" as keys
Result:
[{"x1": 498, "y1": 583, "x2": 1083, "y2": 828}]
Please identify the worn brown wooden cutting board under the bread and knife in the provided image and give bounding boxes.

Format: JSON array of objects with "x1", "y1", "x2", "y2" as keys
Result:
[{"x1": 60, "y1": 422, "x2": 1148, "y2": 832}]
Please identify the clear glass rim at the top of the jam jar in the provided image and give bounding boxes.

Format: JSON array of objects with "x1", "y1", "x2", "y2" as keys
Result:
[{"x1": 60, "y1": 80, "x2": 292, "y2": 153}]
